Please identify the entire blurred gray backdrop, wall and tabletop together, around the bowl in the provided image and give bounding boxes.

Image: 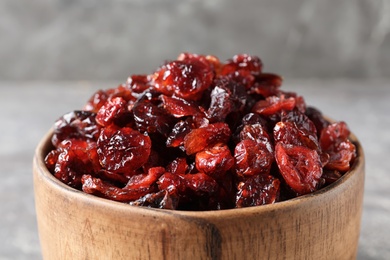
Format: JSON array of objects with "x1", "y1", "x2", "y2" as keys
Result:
[{"x1": 0, "y1": 0, "x2": 390, "y2": 260}]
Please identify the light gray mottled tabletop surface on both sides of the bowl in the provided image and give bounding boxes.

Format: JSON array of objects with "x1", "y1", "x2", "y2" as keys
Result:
[{"x1": 0, "y1": 79, "x2": 390, "y2": 260}]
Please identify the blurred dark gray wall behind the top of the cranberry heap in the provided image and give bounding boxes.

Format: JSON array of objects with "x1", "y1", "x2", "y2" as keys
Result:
[{"x1": 0, "y1": 0, "x2": 390, "y2": 81}]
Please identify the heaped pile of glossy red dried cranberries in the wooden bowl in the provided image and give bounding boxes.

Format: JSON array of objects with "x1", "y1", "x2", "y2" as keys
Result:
[{"x1": 45, "y1": 53, "x2": 356, "y2": 210}]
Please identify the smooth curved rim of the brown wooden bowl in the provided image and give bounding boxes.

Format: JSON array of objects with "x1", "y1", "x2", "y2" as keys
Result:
[{"x1": 33, "y1": 128, "x2": 365, "y2": 218}]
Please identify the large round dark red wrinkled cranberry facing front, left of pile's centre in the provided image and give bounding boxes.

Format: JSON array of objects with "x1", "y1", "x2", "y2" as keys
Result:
[{"x1": 97, "y1": 127, "x2": 152, "y2": 173}]
